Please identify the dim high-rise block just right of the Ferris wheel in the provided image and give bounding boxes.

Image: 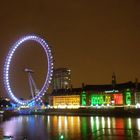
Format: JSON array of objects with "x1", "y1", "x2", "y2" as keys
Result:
[{"x1": 52, "y1": 68, "x2": 71, "y2": 90}]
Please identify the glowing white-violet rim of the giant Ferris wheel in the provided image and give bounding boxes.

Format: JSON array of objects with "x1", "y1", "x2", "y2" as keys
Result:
[{"x1": 4, "y1": 35, "x2": 53, "y2": 105}]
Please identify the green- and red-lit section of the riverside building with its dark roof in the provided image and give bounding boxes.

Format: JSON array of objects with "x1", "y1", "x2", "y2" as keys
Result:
[{"x1": 81, "y1": 82, "x2": 135, "y2": 106}]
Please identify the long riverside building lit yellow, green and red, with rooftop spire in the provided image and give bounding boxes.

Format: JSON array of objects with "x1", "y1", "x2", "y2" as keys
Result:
[{"x1": 50, "y1": 74, "x2": 140, "y2": 108}]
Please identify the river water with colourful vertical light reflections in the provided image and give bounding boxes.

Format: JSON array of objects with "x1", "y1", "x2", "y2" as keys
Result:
[{"x1": 0, "y1": 115, "x2": 140, "y2": 140}]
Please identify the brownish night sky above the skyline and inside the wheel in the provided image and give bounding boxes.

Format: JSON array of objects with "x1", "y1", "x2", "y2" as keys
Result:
[{"x1": 0, "y1": 0, "x2": 140, "y2": 97}]
